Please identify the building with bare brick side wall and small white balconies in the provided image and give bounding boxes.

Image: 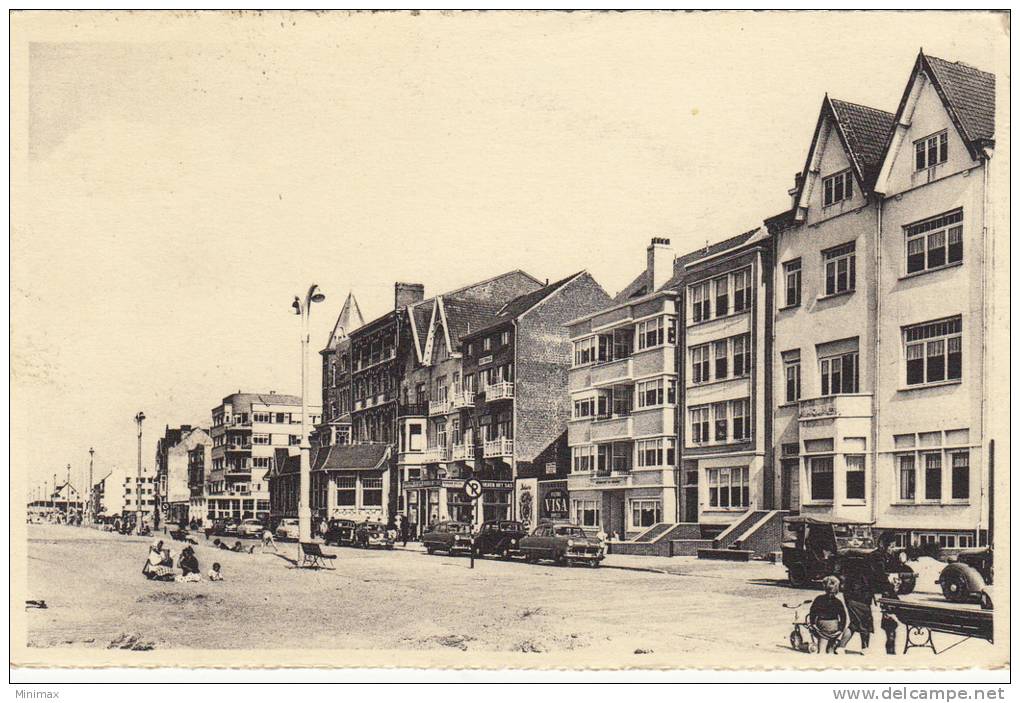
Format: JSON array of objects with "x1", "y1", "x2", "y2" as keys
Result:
[{"x1": 463, "y1": 271, "x2": 611, "y2": 526}]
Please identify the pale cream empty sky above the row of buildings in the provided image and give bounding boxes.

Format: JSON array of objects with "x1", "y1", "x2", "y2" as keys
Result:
[{"x1": 11, "y1": 12, "x2": 1009, "y2": 489}]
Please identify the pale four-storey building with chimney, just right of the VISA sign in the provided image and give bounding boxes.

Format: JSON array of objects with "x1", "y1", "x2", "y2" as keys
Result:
[{"x1": 567, "y1": 238, "x2": 682, "y2": 539}]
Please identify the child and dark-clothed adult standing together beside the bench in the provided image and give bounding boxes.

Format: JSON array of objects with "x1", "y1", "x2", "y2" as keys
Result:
[{"x1": 808, "y1": 534, "x2": 898, "y2": 654}]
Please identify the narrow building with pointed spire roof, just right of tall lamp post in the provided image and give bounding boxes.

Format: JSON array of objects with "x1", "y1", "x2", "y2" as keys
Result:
[{"x1": 311, "y1": 293, "x2": 365, "y2": 446}]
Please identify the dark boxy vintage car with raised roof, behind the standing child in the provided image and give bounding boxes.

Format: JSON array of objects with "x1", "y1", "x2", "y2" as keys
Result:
[{"x1": 782, "y1": 515, "x2": 917, "y2": 595}]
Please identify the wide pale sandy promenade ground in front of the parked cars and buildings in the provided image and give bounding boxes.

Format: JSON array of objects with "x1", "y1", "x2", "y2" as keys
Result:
[{"x1": 28, "y1": 525, "x2": 971, "y2": 666}]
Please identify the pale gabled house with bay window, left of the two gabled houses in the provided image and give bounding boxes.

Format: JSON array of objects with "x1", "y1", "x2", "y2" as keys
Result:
[{"x1": 767, "y1": 96, "x2": 894, "y2": 520}]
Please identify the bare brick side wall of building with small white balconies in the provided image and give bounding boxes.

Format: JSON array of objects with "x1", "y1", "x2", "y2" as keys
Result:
[{"x1": 514, "y1": 272, "x2": 611, "y2": 462}]
